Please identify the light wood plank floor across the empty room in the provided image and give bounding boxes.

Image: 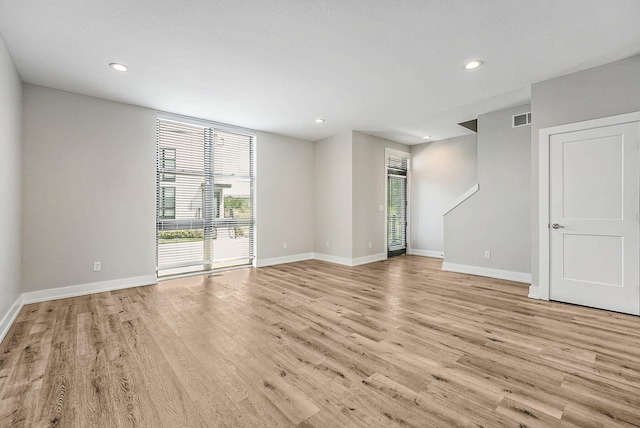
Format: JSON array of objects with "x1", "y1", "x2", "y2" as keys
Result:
[{"x1": 0, "y1": 256, "x2": 640, "y2": 428}]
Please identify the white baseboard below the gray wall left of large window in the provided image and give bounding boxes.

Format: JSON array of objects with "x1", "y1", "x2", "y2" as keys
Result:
[{"x1": 22, "y1": 275, "x2": 158, "y2": 305}]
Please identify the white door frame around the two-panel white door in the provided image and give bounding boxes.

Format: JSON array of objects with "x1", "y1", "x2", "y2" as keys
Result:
[{"x1": 529, "y1": 111, "x2": 640, "y2": 300}]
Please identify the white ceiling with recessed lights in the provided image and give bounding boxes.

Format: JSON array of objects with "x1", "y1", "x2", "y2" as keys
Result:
[{"x1": 0, "y1": 0, "x2": 640, "y2": 144}]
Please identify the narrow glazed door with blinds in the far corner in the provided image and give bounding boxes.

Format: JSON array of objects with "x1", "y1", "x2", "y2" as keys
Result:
[{"x1": 386, "y1": 151, "x2": 408, "y2": 256}]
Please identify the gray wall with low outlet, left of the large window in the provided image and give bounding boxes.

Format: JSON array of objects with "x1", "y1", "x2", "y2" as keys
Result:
[{"x1": 22, "y1": 84, "x2": 156, "y2": 291}]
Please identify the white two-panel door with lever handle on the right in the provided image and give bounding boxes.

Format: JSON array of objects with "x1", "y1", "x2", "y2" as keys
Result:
[{"x1": 549, "y1": 122, "x2": 640, "y2": 315}]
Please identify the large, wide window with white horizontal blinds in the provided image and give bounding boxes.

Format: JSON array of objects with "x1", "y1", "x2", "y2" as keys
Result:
[{"x1": 156, "y1": 118, "x2": 255, "y2": 276}]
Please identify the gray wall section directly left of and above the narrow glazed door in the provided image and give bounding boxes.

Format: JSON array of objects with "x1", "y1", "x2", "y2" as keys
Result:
[{"x1": 352, "y1": 131, "x2": 409, "y2": 258}]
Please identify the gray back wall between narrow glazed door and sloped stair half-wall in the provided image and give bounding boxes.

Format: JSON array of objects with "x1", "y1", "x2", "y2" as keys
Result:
[{"x1": 410, "y1": 134, "x2": 478, "y2": 254}]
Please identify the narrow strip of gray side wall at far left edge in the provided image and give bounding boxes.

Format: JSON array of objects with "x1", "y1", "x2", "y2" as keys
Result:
[{"x1": 0, "y1": 38, "x2": 22, "y2": 320}]
